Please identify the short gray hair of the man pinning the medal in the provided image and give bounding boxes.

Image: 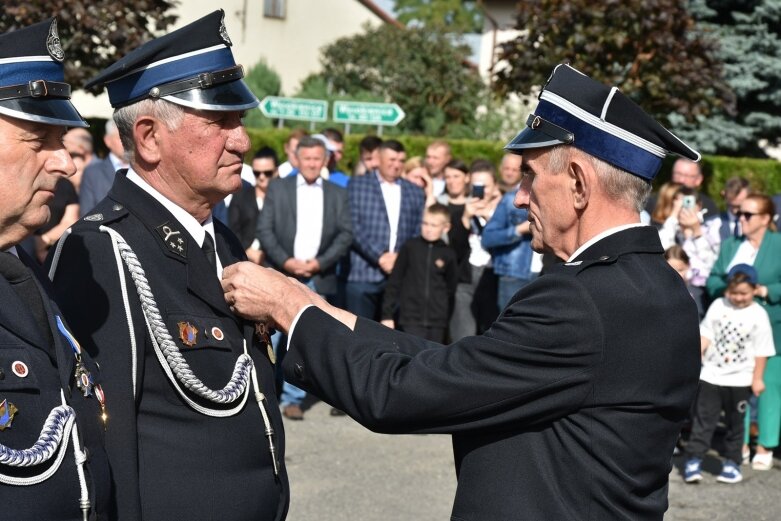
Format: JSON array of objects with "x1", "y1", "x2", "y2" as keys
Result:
[{"x1": 548, "y1": 145, "x2": 651, "y2": 212}]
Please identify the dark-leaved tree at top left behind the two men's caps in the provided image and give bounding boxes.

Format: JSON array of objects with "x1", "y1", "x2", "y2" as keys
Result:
[{"x1": 0, "y1": 0, "x2": 179, "y2": 88}]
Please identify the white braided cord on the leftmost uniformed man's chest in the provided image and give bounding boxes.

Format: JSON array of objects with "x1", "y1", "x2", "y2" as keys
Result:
[{"x1": 0, "y1": 405, "x2": 76, "y2": 485}]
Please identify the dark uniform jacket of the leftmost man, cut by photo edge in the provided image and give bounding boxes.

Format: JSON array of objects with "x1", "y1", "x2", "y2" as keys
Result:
[{"x1": 0, "y1": 248, "x2": 111, "y2": 521}]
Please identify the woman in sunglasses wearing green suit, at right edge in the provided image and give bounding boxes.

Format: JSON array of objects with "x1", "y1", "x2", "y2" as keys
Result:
[{"x1": 706, "y1": 193, "x2": 781, "y2": 470}]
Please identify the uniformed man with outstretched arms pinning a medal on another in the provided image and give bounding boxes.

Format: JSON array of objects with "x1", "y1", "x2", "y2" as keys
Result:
[{"x1": 223, "y1": 65, "x2": 700, "y2": 521}]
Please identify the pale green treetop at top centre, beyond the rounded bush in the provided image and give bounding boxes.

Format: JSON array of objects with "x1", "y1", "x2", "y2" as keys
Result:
[{"x1": 394, "y1": 0, "x2": 483, "y2": 33}]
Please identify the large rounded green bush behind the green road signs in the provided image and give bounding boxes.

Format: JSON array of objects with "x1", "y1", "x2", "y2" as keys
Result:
[{"x1": 308, "y1": 24, "x2": 484, "y2": 135}]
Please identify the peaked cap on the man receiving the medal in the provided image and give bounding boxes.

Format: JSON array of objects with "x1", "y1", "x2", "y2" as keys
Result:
[{"x1": 87, "y1": 9, "x2": 260, "y2": 111}]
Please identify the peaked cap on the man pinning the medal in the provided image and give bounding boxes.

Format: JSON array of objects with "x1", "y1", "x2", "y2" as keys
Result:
[{"x1": 505, "y1": 64, "x2": 700, "y2": 182}]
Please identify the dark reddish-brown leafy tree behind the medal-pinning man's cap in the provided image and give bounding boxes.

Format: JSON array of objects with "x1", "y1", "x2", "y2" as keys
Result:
[{"x1": 495, "y1": 0, "x2": 733, "y2": 129}]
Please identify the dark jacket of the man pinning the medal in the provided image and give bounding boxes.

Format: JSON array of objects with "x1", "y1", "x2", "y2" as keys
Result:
[{"x1": 284, "y1": 227, "x2": 700, "y2": 521}]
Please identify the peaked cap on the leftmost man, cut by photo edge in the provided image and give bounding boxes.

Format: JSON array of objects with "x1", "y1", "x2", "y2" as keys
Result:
[{"x1": 0, "y1": 18, "x2": 89, "y2": 127}]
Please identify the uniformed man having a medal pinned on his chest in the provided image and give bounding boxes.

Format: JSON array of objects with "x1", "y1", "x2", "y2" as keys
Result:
[{"x1": 51, "y1": 11, "x2": 288, "y2": 521}]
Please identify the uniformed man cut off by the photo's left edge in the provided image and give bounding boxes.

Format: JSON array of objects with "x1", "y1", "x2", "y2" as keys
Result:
[{"x1": 0, "y1": 19, "x2": 111, "y2": 521}]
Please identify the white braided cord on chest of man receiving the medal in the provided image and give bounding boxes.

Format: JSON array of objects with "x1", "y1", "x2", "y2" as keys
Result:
[{"x1": 100, "y1": 226, "x2": 253, "y2": 410}]
